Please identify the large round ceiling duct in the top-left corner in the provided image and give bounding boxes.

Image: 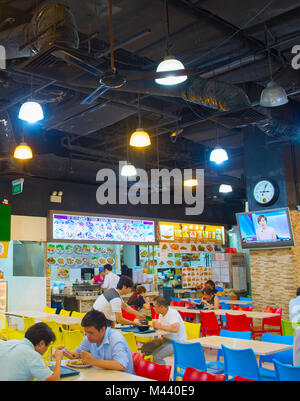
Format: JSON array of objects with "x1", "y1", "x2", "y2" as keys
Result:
[{"x1": 0, "y1": 2, "x2": 79, "y2": 60}]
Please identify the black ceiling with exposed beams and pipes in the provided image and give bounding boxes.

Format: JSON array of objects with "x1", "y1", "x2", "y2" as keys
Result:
[{"x1": 0, "y1": 0, "x2": 300, "y2": 205}]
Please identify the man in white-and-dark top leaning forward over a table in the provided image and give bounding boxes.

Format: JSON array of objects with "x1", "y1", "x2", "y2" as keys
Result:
[{"x1": 93, "y1": 276, "x2": 144, "y2": 326}]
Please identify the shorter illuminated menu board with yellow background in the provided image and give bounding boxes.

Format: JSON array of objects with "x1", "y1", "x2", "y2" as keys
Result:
[{"x1": 159, "y1": 221, "x2": 225, "y2": 245}]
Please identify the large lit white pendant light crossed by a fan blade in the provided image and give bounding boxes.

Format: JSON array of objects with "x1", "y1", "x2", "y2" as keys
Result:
[{"x1": 155, "y1": 0, "x2": 187, "y2": 85}]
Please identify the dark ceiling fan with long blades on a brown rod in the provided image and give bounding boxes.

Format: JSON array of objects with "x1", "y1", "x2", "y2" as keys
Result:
[{"x1": 52, "y1": 0, "x2": 198, "y2": 104}]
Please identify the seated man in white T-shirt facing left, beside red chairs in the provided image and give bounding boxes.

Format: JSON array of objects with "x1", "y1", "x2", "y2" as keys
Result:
[{"x1": 142, "y1": 296, "x2": 187, "y2": 365}]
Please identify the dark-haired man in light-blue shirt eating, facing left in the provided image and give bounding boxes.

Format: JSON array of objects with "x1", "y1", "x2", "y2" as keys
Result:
[{"x1": 65, "y1": 309, "x2": 134, "y2": 374}]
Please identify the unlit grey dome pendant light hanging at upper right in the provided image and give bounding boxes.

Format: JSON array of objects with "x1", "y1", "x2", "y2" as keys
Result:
[{"x1": 260, "y1": 24, "x2": 289, "y2": 107}]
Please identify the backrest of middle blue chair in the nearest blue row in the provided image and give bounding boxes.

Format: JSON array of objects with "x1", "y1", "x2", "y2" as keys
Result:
[{"x1": 222, "y1": 344, "x2": 260, "y2": 380}]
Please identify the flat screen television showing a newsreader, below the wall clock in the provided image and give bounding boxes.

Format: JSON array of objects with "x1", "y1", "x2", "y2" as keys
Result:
[{"x1": 236, "y1": 208, "x2": 295, "y2": 249}]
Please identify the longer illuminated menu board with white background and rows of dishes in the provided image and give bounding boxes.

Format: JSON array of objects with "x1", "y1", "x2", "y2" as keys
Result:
[{"x1": 48, "y1": 211, "x2": 156, "y2": 244}]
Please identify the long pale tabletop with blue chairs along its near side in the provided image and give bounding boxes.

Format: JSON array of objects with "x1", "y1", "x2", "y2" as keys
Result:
[{"x1": 181, "y1": 336, "x2": 293, "y2": 356}]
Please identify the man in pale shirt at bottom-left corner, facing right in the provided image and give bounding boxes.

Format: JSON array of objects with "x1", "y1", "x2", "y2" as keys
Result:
[{"x1": 0, "y1": 323, "x2": 63, "y2": 381}]
